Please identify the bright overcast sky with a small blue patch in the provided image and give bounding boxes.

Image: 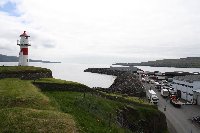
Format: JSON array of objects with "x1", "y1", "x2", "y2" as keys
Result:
[{"x1": 0, "y1": 0, "x2": 200, "y2": 64}]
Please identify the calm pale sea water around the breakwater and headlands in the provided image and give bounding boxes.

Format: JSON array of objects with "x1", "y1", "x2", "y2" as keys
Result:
[{"x1": 0, "y1": 62, "x2": 200, "y2": 88}]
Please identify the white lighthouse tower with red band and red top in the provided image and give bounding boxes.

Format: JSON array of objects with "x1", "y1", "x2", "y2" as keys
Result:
[{"x1": 17, "y1": 31, "x2": 31, "y2": 66}]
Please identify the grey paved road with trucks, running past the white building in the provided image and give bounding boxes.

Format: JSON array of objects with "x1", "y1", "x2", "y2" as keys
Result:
[{"x1": 144, "y1": 83, "x2": 200, "y2": 133}]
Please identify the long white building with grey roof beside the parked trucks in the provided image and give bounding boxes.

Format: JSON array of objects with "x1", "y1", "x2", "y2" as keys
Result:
[{"x1": 171, "y1": 75, "x2": 200, "y2": 105}]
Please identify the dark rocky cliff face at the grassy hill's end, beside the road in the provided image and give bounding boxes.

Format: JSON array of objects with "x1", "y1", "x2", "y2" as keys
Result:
[{"x1": 117, "y1": 106, "x2": 167, "y2": 133}]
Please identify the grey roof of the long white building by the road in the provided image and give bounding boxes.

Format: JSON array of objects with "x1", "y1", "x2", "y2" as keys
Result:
[{"x1": 173, "y1": 75, "x2": 200, "y2": 82}]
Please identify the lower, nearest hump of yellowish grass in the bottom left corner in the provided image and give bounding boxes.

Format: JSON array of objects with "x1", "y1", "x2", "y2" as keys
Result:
[{"x1": 0, "y1": 107, "x2": 76, "y2": 133}]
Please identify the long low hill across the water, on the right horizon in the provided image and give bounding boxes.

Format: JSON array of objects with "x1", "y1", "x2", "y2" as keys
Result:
[{"x1": 114, "y1": 57, "x2": 200, "y2": 68}]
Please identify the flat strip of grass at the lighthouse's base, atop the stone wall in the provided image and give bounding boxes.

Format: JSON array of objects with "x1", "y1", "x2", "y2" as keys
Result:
[{"x1": 0, "y1": 66, "x2": 51, "y2": 73}]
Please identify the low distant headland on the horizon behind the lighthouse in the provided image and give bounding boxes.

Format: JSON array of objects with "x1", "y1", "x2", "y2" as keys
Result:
[{"x1": 0, "y1": 54, "x2": 61, "y2": 63}]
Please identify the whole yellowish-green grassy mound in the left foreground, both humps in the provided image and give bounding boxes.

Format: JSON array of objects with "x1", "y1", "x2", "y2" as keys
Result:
[{"x1": 0, "y1": 79, "x2": 76, "y2": 132}]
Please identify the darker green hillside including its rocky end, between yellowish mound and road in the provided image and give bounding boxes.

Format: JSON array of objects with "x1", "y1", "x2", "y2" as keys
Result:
[{"x1": 35, "y1": 79, "x2": 167, "y2": 133}]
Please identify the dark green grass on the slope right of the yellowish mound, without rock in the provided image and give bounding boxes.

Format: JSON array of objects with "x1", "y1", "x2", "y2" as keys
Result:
[{"x1": 44, "y1": 91, "x2": 164, "y2": 133}]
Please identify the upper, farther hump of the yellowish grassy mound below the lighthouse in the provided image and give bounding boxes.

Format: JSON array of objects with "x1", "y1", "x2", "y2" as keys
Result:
[{"x1": 0, "y1": 79, "x2": 53, "y2": 110}]
